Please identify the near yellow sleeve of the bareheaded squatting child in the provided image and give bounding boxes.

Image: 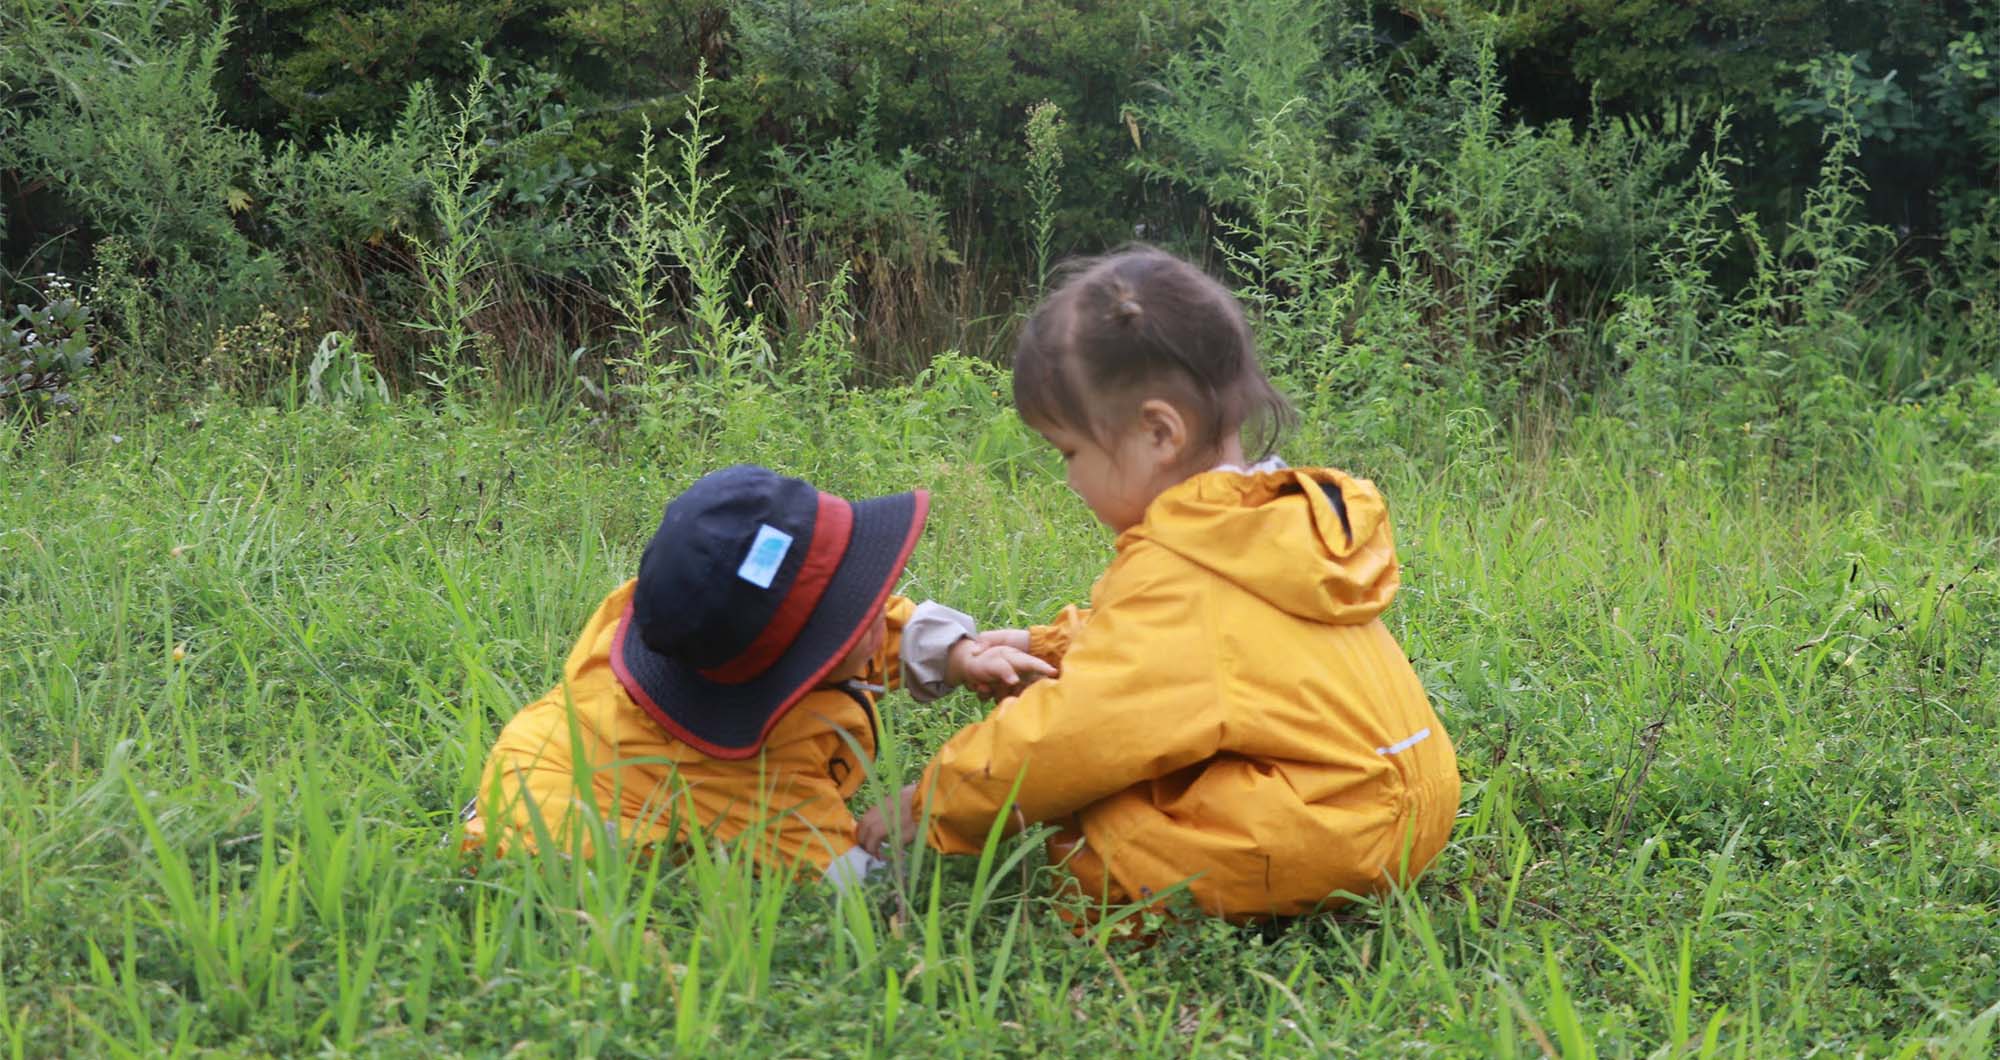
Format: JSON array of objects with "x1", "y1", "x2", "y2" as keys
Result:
[{"x1": 916, "y1": 546, "x2": 1224, "y2": 854}]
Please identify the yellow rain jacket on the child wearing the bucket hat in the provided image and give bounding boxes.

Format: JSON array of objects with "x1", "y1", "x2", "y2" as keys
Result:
[{"x1": 466, "y1": 582, "x2": 914, "y2": 870}]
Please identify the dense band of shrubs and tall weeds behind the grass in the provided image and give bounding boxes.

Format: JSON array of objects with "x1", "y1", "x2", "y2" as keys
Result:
[{"x1": 0, "y1": 0, "x2": 2000, "y2": 454}]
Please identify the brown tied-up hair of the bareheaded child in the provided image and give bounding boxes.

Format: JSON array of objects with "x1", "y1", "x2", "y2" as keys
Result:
[{"x1": 1014, "y1": 246, "x2": 1298, "y2": 460}]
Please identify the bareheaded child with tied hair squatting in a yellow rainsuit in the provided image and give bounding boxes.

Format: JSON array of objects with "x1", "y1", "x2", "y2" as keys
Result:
[{"x1": 862, "y1": 248, "x2": 1458, "y2": 922}]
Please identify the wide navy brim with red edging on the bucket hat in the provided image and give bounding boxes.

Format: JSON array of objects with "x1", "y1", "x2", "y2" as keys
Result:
[{"x1": 612, "y1": 490, "x2": 930, "y2": 758}]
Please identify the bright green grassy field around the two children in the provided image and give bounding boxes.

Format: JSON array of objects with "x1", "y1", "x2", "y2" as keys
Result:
[{"x1": 0, "y1": 362, "x2": 2000, "y2": 1058}]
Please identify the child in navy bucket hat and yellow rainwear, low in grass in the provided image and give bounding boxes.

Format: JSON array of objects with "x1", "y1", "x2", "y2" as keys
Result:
[{"x1": 466, "y1": 466, "x2": 1052, "y2": 882}]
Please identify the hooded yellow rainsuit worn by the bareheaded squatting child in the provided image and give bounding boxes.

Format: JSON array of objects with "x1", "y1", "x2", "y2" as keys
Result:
[{"x1": 916, "y1": 468, "x2": 1458, "y2": 920}]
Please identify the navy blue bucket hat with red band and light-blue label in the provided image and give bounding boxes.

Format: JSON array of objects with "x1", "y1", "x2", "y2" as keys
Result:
[{"x1": 612, "y1": 464, "x2": 930, "y2": 758}]
